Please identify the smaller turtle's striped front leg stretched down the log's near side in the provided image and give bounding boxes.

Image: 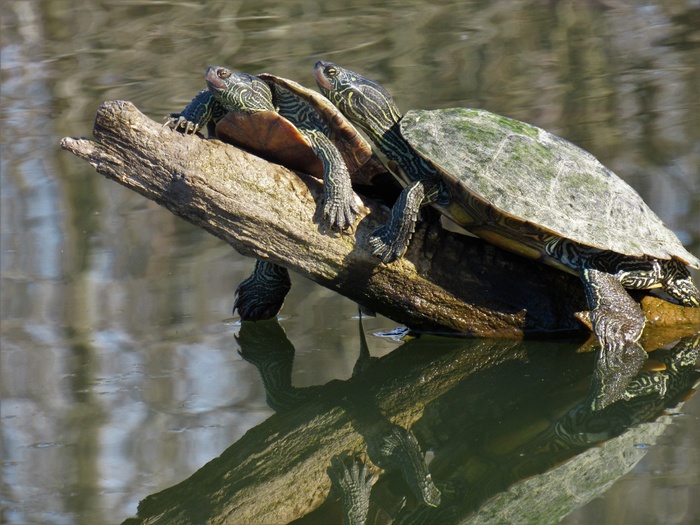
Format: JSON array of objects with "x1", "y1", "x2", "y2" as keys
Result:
[{"x1": 301, "y1": 130, "x2": 360, "y2": 231}]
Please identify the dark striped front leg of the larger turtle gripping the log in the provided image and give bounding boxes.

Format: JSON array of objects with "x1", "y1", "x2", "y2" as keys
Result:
[{"x1": 369, "y1": 180, "x2": 426, "y2": 264}]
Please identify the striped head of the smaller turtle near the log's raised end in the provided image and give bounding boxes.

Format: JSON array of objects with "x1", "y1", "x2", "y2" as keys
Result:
[{"x1": 204, "y1": 66, "x2": 275, "y2": 112}]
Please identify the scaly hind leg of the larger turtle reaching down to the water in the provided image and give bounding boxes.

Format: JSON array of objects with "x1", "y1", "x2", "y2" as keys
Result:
[{"x1": 581, "y1": 268, "x2": 646, "y2": 370}]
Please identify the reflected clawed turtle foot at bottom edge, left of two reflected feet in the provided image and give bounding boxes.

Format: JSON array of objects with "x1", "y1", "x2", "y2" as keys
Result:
[{"x1": 328, "y1": 455, "x2": 372, "y2": 525}]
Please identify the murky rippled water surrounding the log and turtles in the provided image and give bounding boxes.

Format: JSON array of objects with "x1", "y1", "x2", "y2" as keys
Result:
[{"x1": 0, "y1": 0, "x2": 700, "y2": 524}]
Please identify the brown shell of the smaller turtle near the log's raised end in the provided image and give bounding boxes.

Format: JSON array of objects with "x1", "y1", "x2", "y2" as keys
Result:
[{"x1": 216, "y1": 73, "x2": 389, "y2": 185}]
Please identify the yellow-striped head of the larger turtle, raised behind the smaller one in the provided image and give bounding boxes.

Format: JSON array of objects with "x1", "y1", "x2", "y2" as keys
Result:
[{"x1": 314, "y1": 60, "x2": 401, "y2": 138}]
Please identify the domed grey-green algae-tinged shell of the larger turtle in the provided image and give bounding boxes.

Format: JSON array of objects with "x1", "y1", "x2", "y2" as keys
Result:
[{"x1": 401, "y1": 108, "x2": 700, "y2": 268}]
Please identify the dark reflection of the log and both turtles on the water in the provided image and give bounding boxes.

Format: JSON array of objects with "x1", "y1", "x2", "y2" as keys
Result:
[{"x1": 125, "y1": 319, "x2": 700, "y2": 525}]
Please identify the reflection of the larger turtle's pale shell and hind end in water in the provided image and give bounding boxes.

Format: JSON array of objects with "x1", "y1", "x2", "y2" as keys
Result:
[{"x1": 464, "y1": 336, "x2": 700, "y2": 524}]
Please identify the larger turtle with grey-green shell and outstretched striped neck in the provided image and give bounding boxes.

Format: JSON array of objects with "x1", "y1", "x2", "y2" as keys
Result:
[{"x1": 314, "y1": 61, "x2": 700, "y2": 356}]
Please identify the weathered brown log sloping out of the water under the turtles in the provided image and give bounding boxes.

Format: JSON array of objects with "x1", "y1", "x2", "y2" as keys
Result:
[{"x1": 61, "y1": 101, "x2": 700, "y2": 337}]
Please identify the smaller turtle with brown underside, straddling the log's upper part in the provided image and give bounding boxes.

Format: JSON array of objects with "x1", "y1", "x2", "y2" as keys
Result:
[{"x1": 165, "y1": 66, "x2": 398, "y2": 320}]
